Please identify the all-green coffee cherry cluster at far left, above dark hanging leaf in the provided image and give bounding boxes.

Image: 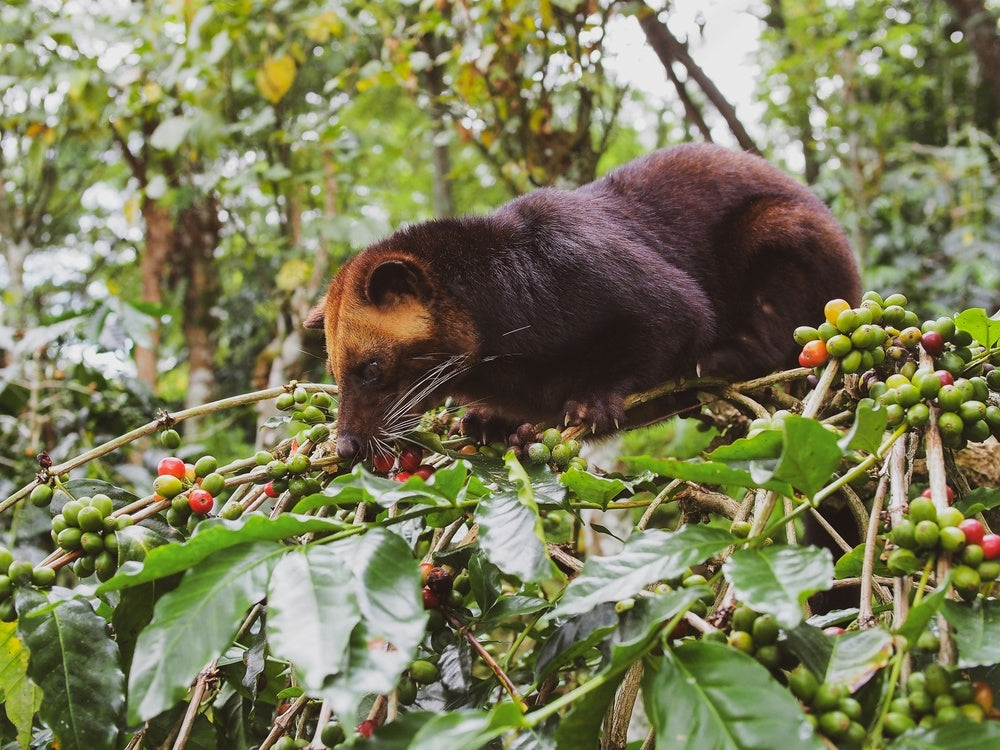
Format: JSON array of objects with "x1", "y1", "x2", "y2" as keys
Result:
[{"x1": 52, "y1": 493, "x2": 132, "y2": 581}]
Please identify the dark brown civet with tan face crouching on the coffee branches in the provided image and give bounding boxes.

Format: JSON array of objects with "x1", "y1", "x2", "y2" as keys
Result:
[{"x1": 307, "y1": 140, "x2": 860, "y2": 457}]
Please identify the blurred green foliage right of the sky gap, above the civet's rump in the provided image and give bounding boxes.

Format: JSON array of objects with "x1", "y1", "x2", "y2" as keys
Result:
[{"x1": 760, "y1": 0, "x2": 1000, "y2": 316}]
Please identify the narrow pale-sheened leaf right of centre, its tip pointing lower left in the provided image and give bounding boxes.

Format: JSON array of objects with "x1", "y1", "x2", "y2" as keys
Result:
[{"x1": 553, "y1": 524, "x2": 738, "y2": 617}]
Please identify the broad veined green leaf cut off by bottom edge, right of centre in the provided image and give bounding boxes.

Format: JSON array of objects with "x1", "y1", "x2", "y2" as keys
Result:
[{"x1": 642, "y1": 641, "x2": 824, "y2": 750}]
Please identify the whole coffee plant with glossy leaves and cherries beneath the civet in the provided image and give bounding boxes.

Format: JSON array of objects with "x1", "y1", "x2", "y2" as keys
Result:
[{"x1": 0, "y1": 292, "x2": 1000, "y2": 750}]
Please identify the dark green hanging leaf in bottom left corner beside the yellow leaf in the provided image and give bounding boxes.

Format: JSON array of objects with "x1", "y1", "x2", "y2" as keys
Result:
[{"x1": 17, "y1": 588, "x2": 125, "y2": 750}]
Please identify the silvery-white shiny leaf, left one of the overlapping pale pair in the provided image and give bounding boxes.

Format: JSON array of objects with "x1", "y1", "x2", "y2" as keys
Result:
[{"x1": 267, "y1": 545, "x2": 361, "y2": 694}]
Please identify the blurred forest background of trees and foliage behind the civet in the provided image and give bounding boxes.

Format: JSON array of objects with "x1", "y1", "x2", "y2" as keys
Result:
[{"x1": 0, "y1": 0, "x2": 1000, "y2": 524}]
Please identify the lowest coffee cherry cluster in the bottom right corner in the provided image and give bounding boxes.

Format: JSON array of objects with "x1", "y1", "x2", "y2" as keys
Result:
[{"x1": 885, "y1": 662, "x2": 995, "y2": 736}]
